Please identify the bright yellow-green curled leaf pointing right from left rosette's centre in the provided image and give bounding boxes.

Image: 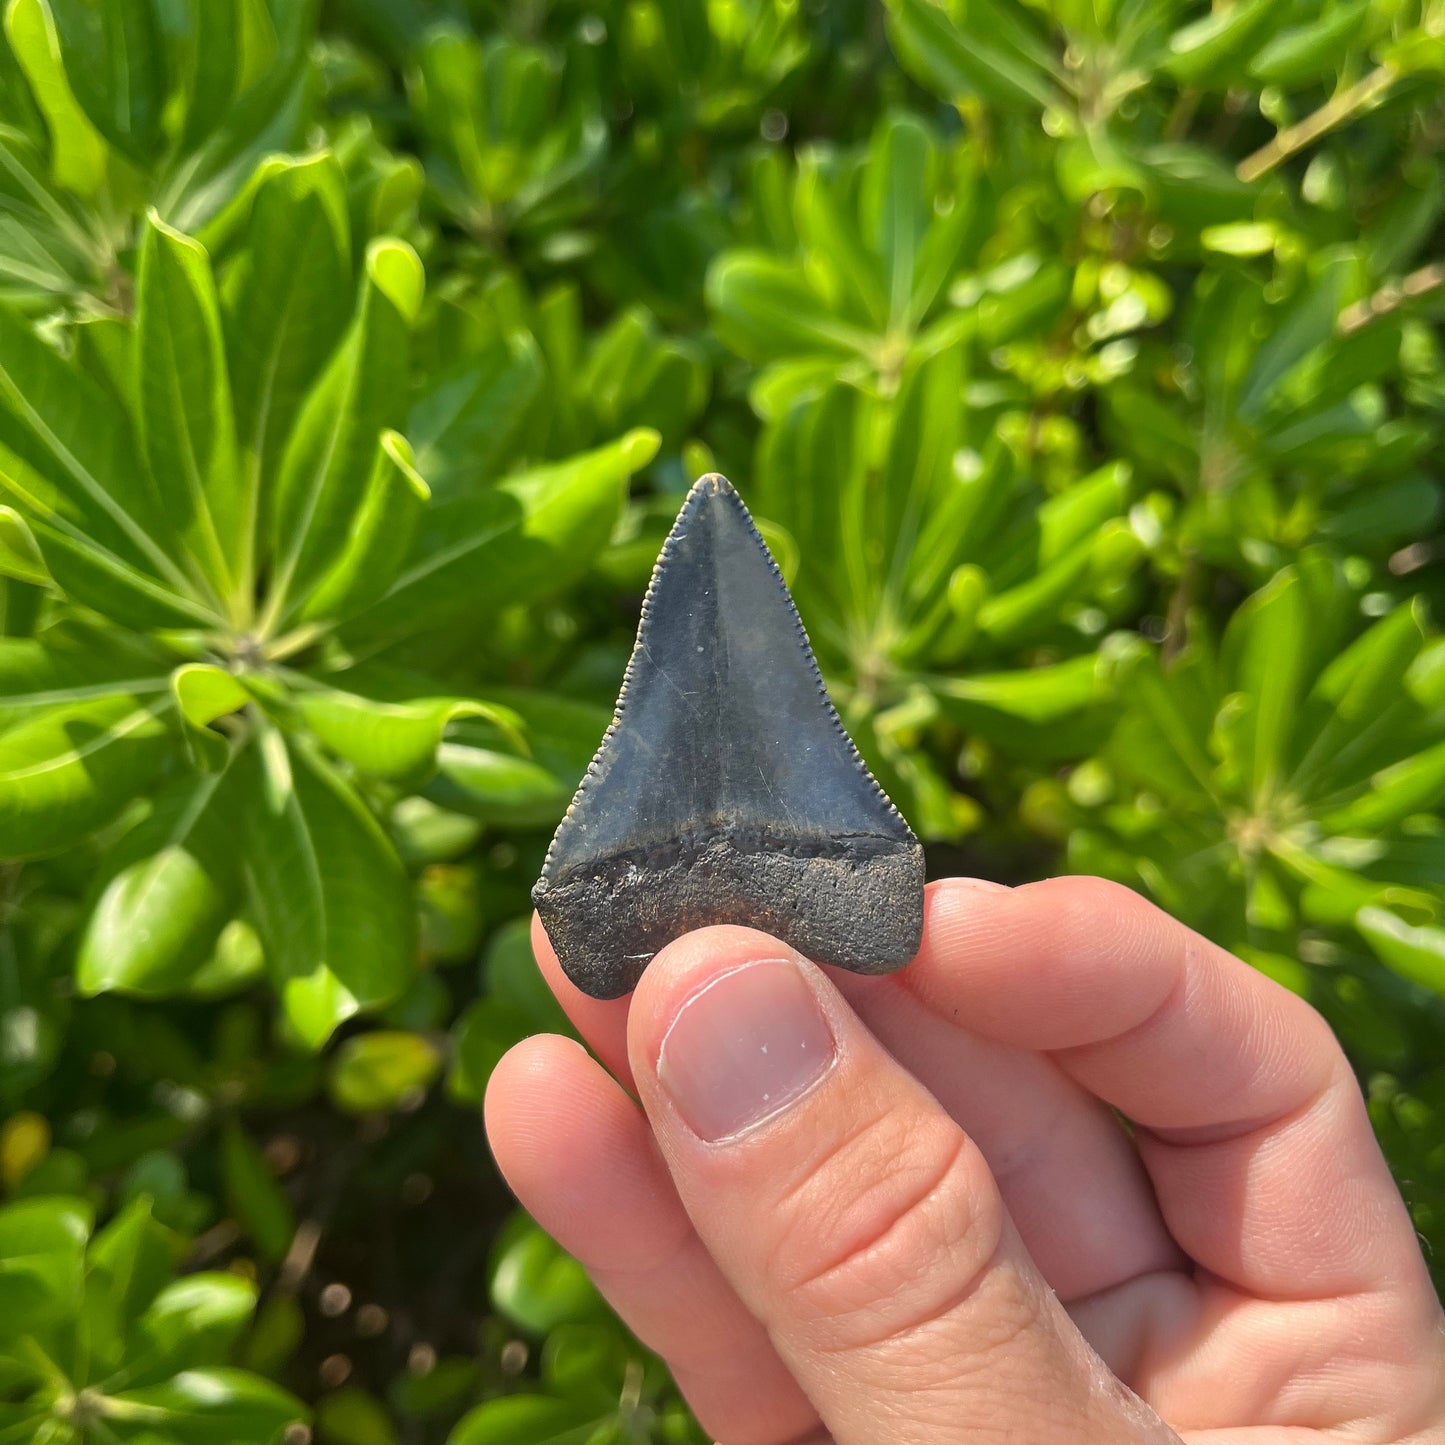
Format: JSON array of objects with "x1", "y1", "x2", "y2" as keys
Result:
[{"x1": 293, "y1": 686, "x2": 496, "y2": 777}]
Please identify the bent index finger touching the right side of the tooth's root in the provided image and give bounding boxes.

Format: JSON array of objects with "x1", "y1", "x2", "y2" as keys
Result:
[{"x1": 902, "y1": 877, "x2": 1429, "y2": 1299}]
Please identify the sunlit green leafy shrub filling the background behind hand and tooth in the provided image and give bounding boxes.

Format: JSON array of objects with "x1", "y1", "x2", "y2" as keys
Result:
[{"x1": 0, "y1": 0, "x2": 1445, "y2": 1445}]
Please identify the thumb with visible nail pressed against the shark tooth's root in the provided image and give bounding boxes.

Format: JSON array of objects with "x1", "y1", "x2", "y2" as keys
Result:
[{"x1": 629, "y1": 928, "x2": 1176, "y2": 1445}]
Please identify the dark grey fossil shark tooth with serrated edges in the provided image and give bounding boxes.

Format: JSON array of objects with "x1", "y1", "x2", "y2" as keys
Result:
[{"x1": 532, "y1": 475, "x2": 923, "y2": 998}]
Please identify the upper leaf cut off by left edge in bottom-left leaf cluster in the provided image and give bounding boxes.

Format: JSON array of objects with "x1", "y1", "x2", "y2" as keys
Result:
[{"x1": 0, "y1": 1196, "x2": 91, "y2": 1340}]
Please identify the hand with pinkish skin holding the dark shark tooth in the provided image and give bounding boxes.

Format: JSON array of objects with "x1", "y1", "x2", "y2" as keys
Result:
[{"x1": 487, "y1": 879, "x2": 1445, "y2": 1445}]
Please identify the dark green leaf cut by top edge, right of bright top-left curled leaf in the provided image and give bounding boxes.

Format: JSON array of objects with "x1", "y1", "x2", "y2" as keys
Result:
[{"x1": 49, "y1": 0, "x2": 166, "y2": 166}]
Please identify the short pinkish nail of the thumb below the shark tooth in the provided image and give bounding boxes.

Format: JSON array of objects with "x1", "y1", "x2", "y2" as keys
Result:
[{"x1": 657, "y1": 958, "x2": 837, "y2": 1143}]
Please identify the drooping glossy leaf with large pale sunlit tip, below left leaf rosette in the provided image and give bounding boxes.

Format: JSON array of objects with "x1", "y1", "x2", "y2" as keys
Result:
[{"x1": 75, "y1": 775, "x2": 240, "y2": 997}]
